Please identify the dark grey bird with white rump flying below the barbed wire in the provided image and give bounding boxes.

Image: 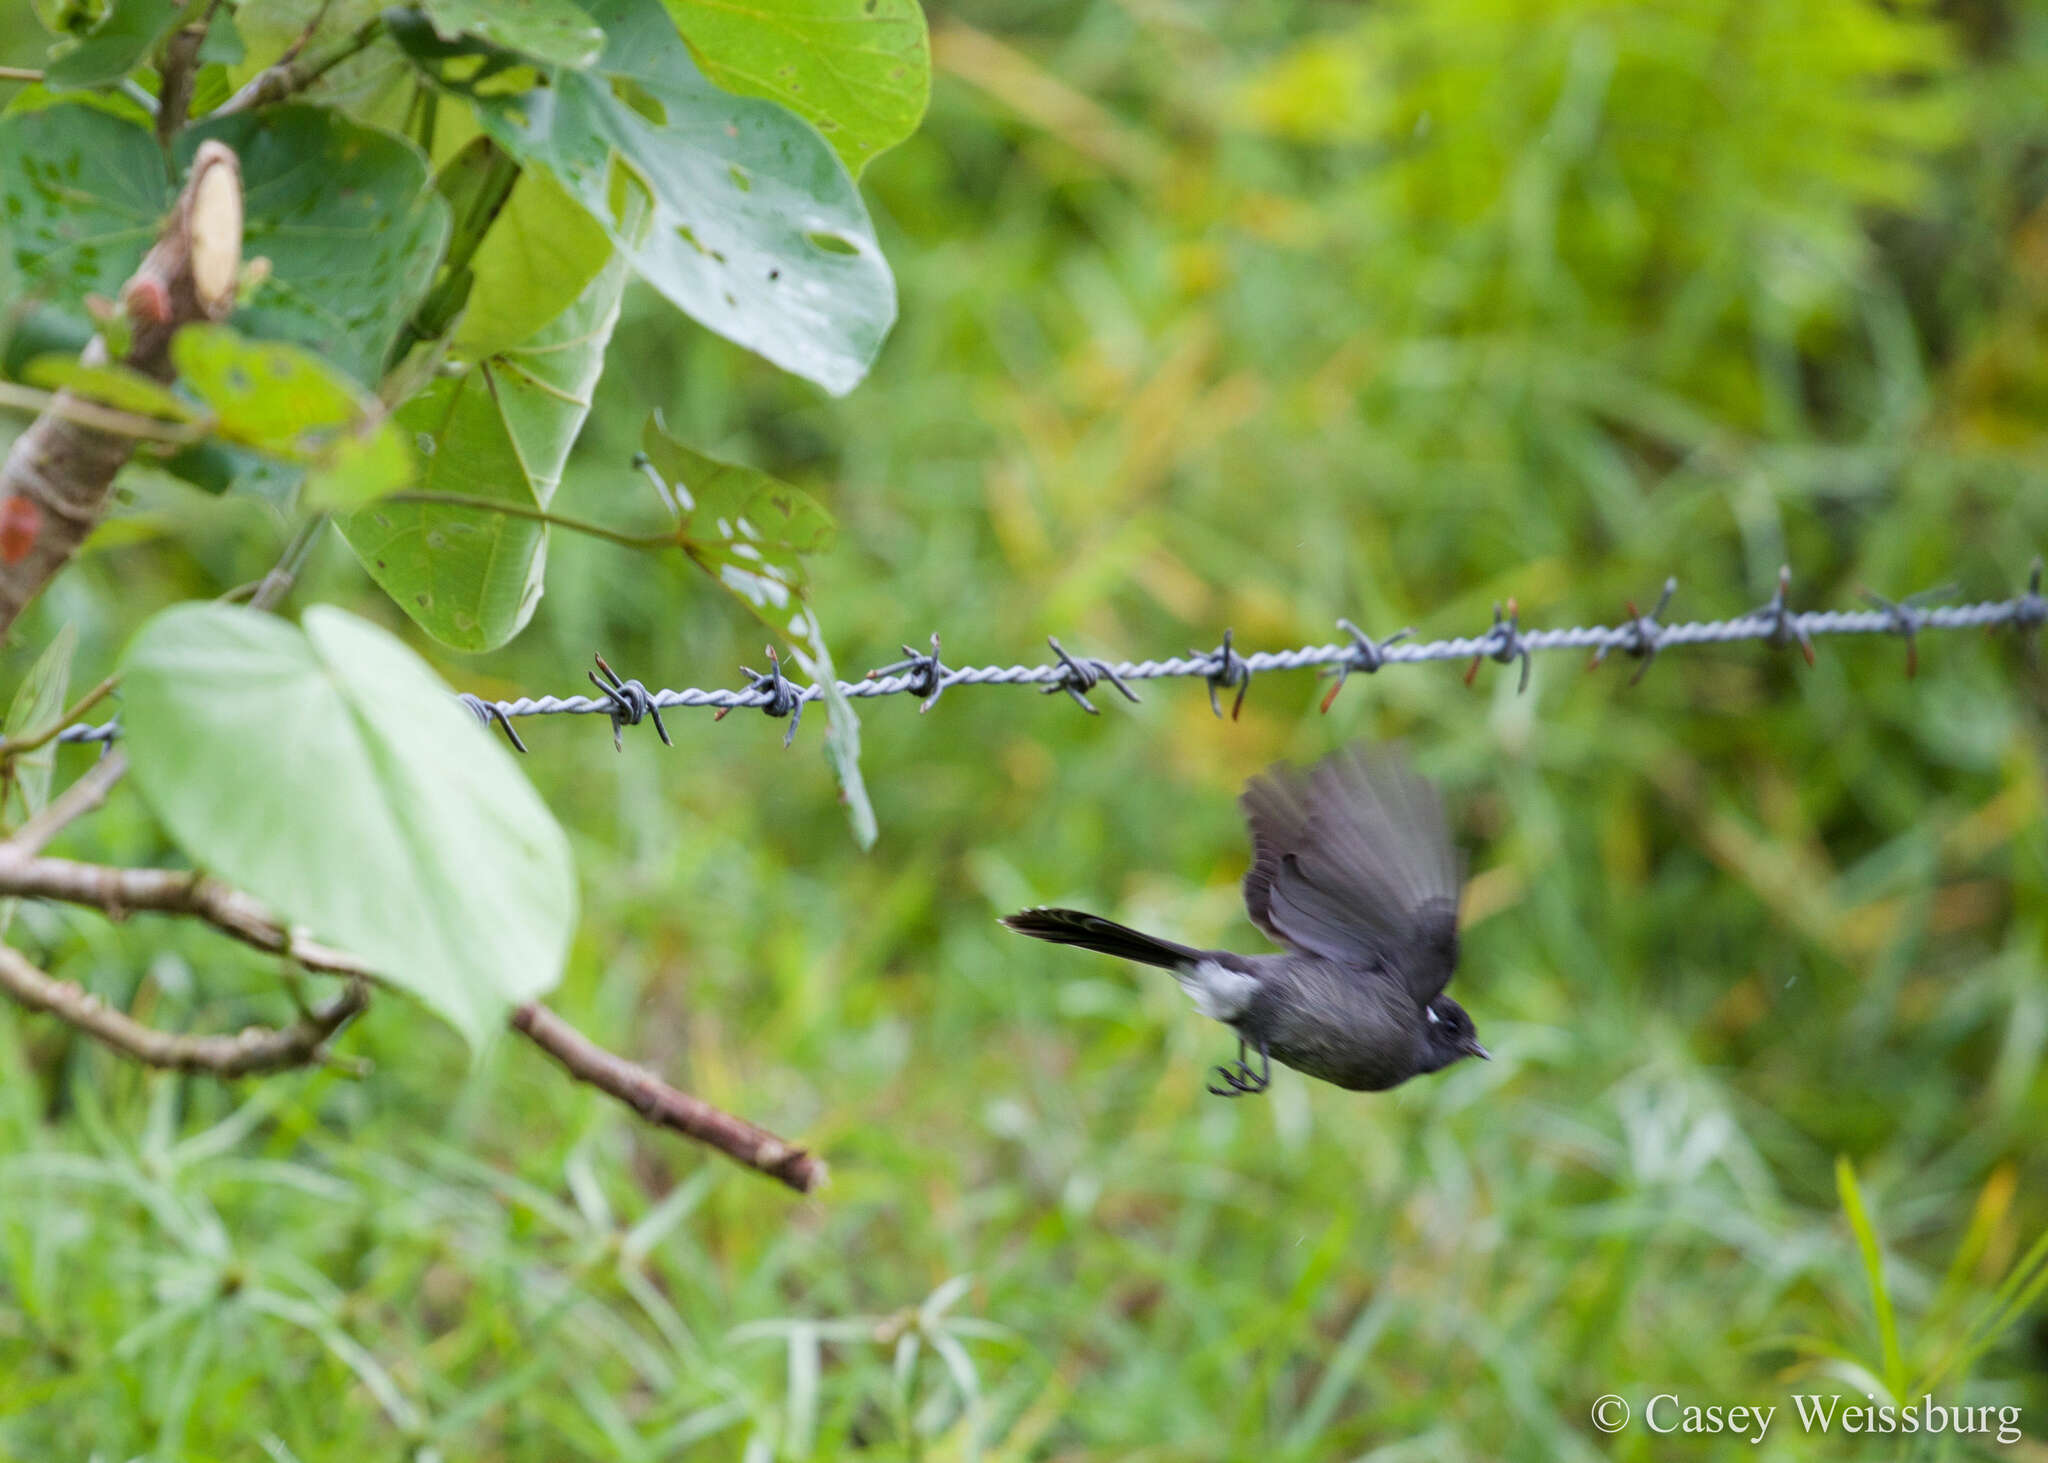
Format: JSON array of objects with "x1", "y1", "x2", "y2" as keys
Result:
[{"x1": 1001, "y1": 744, "x2": 1491, "y2": 1098}]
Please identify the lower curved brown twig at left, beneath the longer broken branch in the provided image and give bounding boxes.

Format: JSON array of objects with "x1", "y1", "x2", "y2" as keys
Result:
[{"x1": 0, "y1": 945, "x2": 369, "y2": 1078}]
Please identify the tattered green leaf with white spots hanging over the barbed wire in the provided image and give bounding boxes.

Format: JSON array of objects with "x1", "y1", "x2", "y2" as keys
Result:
[{"x1": 641, "y1": 418, "x2": 877, "y2": 848}]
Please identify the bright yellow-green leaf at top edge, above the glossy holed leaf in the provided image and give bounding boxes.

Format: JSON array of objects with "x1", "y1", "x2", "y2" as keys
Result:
[{"x1": 666, "y1": 0, "x2": 932, "y2": 178}]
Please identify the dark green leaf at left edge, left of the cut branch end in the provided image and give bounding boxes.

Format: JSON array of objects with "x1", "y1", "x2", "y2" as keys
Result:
[{"x1": 0, "y1": 100, "x2": 172, "y2": 309}]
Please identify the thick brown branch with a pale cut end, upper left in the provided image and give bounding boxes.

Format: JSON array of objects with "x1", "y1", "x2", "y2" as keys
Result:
[{"x1": 0, "y1": 141, "x2": 242, "y2": 635}]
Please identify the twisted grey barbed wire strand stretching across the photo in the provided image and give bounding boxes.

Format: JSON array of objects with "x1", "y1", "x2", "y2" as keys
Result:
[{"x1": 19, "y1": 559, "x2": 2048, "y2": 752}]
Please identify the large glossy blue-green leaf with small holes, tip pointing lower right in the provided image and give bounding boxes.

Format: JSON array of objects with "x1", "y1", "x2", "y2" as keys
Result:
[{"x1": 460, "y1": 0, "x2": 895, "y2": 393}]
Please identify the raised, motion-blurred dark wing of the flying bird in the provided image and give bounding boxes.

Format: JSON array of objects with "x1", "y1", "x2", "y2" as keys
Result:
[{"x1": 1239, "y1": 748, "x2": 1462, "y2": 1004}]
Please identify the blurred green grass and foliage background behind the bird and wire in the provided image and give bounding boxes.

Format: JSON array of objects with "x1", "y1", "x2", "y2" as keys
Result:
[{"x1": 0, "y1": 0, "x2": 2048, "y2": 1461}]
